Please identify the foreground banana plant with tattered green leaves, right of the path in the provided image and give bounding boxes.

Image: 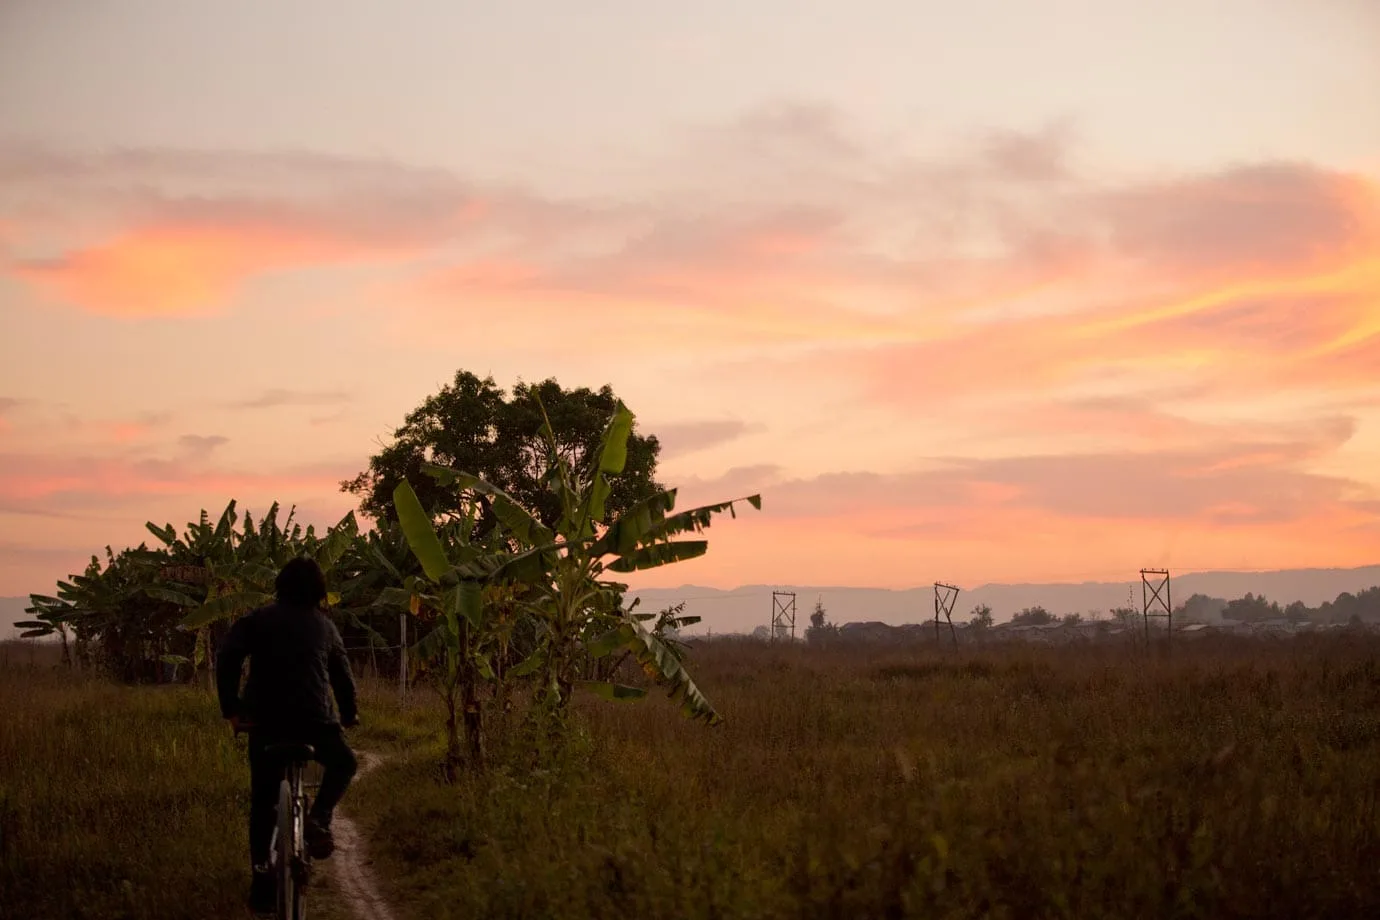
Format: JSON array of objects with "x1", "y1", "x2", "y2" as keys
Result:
[{"x1": 393, "y1": 403, "x2": 762, "y2": 724}]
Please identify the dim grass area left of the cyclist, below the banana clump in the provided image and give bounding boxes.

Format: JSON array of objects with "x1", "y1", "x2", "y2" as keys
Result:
[{"x1": 0, "y1": 643, "x2": 248, "y2": 920}]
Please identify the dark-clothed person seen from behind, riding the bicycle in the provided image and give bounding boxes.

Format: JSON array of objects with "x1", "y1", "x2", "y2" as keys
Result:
[{"x1": 215, "y1": 556, "x2": 359, "y2": 912}]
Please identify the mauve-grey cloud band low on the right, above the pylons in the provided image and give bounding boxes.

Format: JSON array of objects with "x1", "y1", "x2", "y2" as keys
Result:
[{"x1": 697, "y1": 418, "x2": 1380, "y2": 538}]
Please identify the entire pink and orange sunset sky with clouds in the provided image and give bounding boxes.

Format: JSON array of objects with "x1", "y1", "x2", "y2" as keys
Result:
[{"x1": 0, "y1": 0, "x2": 1380, "y2": 594}]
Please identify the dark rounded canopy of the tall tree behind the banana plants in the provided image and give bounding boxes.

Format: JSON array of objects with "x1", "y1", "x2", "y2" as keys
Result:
[{"x1": 341, "y1": 370, "x2": 664, "y2": 527}]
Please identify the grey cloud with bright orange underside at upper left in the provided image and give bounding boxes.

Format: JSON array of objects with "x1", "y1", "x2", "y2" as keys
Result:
[{"x1": 0, "y1": 148, "x2": 607, "y2": 317}]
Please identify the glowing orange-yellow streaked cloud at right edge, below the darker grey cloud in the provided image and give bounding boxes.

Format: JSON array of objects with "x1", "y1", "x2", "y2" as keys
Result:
[{"x1": 798, "y1": 244, "x2": 1380, "y2": 416}]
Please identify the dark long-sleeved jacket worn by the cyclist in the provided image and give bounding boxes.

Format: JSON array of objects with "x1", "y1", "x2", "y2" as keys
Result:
[{"x1": 215, "y1": 604, "x2": 357, "y2": 734}]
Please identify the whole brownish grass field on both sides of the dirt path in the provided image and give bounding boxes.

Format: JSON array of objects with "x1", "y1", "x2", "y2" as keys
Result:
[{"x1": 8, "y1": 636, "x2": 1380, "y2": 919}]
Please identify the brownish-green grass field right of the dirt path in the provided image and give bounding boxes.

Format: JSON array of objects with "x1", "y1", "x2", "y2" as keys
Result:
[{"x1": 342, "y1": 639, "x2": 1380, "y2": 919}]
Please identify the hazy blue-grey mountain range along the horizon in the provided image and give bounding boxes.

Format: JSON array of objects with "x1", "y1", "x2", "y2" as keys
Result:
[{"x1": 0, "y1": 566, "x2": 1380, "y2": 639}]
